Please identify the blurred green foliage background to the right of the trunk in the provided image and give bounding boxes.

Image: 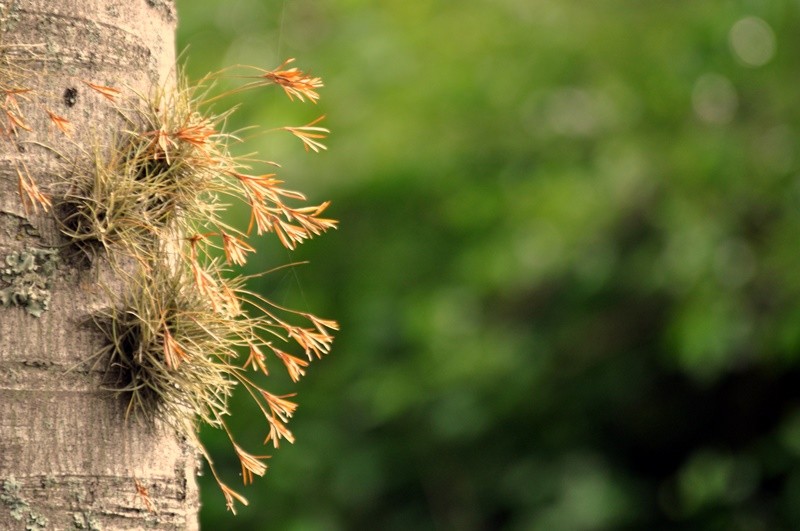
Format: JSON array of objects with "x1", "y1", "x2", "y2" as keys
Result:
[{"x1": 178, "y1": 0, "x2": 800, "y2": 531}]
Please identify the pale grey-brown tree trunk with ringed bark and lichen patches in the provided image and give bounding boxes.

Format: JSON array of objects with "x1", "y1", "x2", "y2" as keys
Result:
[{"x1": 0, "y1": 0, "x2": 199, "y2": 530}]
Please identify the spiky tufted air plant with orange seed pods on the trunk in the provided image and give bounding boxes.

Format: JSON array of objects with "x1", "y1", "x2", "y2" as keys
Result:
[{"x1": 0, "y1": 48, "x2": 338, "y2": 512}]
